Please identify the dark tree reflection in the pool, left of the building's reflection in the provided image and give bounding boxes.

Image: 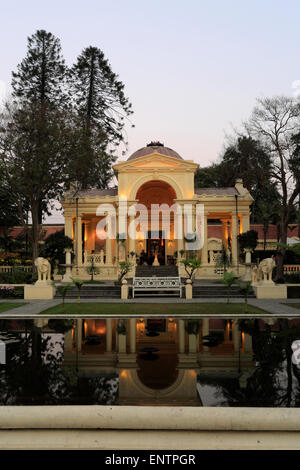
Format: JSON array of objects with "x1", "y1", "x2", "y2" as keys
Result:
[{"x1": 0, "y1": 321, "x2": 118, "y2": 405}]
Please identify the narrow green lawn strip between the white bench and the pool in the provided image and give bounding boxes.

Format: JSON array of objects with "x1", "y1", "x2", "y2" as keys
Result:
[{"x1": 41, "y1": 303, "x2": 266, "y2": 316}]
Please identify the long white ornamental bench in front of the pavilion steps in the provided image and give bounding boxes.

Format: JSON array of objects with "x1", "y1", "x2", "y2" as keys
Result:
[{"x1": 132, "y1": 276, "x2": 182, "y2": 299}]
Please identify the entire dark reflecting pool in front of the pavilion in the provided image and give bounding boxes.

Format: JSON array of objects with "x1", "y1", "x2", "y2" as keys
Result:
[{"x1": 0, "y1": 316, "x2": 300, "y2": 407}]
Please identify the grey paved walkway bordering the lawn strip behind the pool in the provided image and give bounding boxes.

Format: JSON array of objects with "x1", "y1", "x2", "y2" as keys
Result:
[{"x1": 0, "y1": 297, "x2": 300, "y2": 318}]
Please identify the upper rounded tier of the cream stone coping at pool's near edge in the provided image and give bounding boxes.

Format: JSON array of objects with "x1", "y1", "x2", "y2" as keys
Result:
[{"x1": 0, "y1": 405, "x2": 300, "y2": 432}]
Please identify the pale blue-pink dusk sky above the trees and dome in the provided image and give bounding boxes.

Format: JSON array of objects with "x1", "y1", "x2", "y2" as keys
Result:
[{"x1": 0, "y1": 0, "x2": 300, "y2": 220}]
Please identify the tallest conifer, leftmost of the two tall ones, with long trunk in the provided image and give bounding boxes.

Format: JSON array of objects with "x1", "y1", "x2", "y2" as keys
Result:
[{"x1": 7, "y1": 30, "x2": 68, "y2": 256}]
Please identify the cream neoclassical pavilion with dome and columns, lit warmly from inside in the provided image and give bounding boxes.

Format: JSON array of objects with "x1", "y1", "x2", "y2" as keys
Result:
[{"x1": 62, "y1": 142, "x2": 253, "y2": 279}]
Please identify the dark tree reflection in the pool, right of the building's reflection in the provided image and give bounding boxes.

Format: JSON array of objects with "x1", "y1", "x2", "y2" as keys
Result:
[{"x1": 216, "y1": 319, "x2": 300, "y2": 407}]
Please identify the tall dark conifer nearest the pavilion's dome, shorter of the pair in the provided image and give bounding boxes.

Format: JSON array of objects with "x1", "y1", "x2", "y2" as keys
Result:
[{"x1": 69, "y1": 47, "x2": 132, "y2": 188}]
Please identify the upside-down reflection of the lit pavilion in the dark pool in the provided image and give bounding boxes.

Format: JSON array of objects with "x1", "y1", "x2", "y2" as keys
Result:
[{"x1": 64, "y1": 318, "x2": 253, "y2": 405}]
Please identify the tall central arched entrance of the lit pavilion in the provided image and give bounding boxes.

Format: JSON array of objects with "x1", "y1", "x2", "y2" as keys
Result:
[{"x1": 136, "y1": 180, "x2": 177, "y2": 265}]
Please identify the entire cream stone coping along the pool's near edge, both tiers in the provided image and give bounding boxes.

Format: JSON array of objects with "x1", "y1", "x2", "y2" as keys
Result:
[{"x1": 0, "y1": 405, "x2": 300, "y2": 450}]
